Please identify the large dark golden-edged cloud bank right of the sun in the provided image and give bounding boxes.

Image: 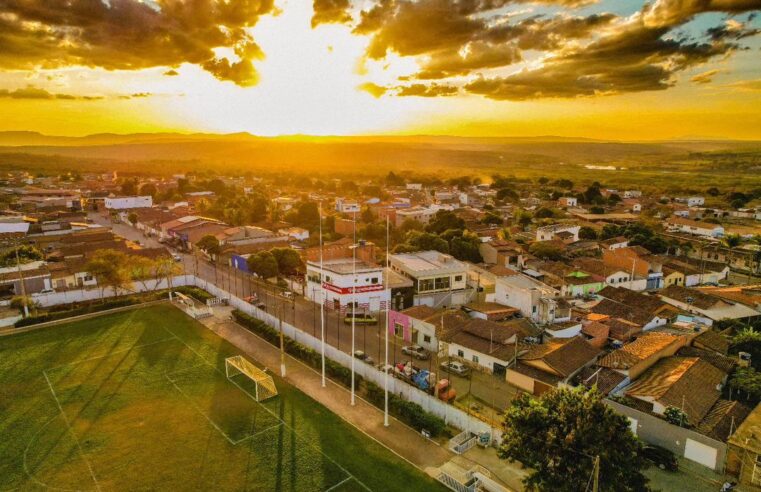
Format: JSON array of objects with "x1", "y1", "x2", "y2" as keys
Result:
[{"x1": 354, "y1": 0, "x2": 761, "y2": 100}]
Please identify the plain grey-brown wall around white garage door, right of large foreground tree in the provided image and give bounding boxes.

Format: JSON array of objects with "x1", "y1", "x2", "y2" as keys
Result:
[{"x1": 605, "y1": 400, "x2": 727, "y2": 473}]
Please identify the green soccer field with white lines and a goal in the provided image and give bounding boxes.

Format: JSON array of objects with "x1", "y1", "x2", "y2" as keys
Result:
[{"x1": 0, "y1": 305, "x2": 440, "y2": 492}]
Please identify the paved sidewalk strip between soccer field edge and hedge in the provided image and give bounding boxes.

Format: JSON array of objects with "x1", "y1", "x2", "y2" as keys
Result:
[{"x1": 201, "y1": 307, "x2": 455, "y2": 477}]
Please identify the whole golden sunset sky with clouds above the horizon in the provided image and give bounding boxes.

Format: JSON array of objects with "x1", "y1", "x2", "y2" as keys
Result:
[{"x1": 0, "y1": 0, "x2": 761, "y2": 140}]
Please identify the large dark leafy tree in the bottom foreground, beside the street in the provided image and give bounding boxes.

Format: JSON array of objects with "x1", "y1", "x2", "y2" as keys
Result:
[{"x1": 498, "y1": 388, "x2": 648, "y2": 492}]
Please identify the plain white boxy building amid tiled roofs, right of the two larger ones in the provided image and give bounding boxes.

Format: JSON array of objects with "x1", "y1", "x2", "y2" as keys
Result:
[{"x1": 494, "y1": 274, "x2": 560, "y2": 323}]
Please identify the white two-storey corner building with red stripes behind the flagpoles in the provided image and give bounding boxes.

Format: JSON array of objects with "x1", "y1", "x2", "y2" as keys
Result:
[{"x1": 305, "y1": 258, "x2": 391, "y2": 312}]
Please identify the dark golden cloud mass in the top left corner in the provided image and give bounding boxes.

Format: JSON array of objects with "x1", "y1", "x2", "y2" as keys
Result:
[{"x1": 0, "y1": 0, "x2": 275, "y2": 85}]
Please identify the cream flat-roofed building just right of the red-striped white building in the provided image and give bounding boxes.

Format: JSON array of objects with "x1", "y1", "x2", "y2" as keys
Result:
[{"x1": 389, "y1": 251, "x2": 472, "y2": 307}]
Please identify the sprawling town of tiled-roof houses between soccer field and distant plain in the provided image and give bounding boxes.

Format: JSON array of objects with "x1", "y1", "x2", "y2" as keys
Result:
[{"x1": 0, "y1": 170, "x2": 761, "y2": 491}]
